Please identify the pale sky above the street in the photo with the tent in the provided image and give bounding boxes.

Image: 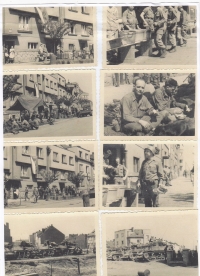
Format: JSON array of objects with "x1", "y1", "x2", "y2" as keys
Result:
[{"x1": 61, "y1": 71, "x2": 95, "y2": 100}]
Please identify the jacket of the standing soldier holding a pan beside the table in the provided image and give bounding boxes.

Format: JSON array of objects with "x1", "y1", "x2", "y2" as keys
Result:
[{"x1": 139, "y1": 157, "x2": 163, "y2": 183}]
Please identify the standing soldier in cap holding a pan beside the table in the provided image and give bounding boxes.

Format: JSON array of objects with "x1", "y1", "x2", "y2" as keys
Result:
[{"x1": 138, "y1": 146, "x2": 163, "y2": 207}]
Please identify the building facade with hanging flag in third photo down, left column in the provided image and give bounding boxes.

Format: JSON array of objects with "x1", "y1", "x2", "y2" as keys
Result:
[{"x1": 4, "y1": 145, "x2": 92, "y2": 198}]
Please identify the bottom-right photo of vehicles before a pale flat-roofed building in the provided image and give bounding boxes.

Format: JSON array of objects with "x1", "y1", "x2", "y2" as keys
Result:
[{"x1": 102, "y1": 210, "x2": 198, "y2": 276}]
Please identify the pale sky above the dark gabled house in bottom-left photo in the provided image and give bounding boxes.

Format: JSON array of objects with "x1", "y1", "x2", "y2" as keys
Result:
[{"x1": 4, "y1": 213, "x2": 95, "y2": 241}]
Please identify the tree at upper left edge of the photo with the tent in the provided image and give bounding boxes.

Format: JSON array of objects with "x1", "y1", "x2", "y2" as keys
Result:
[{"x1": 3, "y1": 75, "x2": 22, "y2": 101}]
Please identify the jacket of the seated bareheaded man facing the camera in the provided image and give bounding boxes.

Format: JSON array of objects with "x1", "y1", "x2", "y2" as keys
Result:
[{"x1": 121, "y1": 92, "x2": 154, "y2": 123}]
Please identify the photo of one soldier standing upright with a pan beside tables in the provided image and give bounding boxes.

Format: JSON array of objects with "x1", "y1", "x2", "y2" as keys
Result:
[{"x1": 101, "y1": 141, "x2": 197, "y2": 209}]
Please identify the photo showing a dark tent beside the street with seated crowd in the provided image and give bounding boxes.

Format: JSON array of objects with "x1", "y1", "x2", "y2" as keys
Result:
[{"x1": 3, "y1": 70, "x2": 95, "y2": 138}]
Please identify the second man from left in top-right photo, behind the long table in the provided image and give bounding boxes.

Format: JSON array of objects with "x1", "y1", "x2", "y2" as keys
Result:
[{"x1": 122, "y1": 6, "x2": 140, "y2": 30}]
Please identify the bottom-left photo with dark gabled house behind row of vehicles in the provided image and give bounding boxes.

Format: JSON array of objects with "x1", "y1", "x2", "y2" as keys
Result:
[{"x1": 4, "y1": 213, "x2": 99, "y2": 276}]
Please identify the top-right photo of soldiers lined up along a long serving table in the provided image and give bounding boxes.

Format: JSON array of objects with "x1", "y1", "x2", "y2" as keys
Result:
[{"x1": 104, "y1": 6, "x2": 197, "y2": 67}]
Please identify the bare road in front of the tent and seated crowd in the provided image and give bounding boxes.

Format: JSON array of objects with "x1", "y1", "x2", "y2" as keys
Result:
[{"x1": 4, "y1": 117, "x2": 93, "y2": 138}]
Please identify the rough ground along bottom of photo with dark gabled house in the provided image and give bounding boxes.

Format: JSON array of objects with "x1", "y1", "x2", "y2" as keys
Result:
[{"x1": 5, "y1": 255, "x2": 96, "y2": 276}]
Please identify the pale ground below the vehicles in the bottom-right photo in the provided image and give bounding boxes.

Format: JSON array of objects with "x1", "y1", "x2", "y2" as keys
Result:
[{"x1": 107, "y1": 261, "x2": 198, "y2": 276}]
